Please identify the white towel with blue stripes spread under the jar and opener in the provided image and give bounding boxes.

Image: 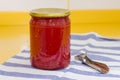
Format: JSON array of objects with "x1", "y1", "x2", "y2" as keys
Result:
[{"x1": 0, "y1": 33, "x2": 120, "y2": 80}]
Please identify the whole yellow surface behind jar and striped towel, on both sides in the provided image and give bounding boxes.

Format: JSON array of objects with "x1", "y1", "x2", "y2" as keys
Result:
[{"x1": 0, "y1": 10, "x2": 120, "y2": 63}]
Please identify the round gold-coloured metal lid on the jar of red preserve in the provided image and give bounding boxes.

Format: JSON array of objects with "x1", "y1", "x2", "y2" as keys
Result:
[{"x1": 30, "y1": 8, "x2": 70, "y2": 17}]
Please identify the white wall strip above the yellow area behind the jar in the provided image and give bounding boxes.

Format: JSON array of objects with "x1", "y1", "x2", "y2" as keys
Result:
[{"x1": 0, "y1": 0, "x2": 120, "y2": 11}]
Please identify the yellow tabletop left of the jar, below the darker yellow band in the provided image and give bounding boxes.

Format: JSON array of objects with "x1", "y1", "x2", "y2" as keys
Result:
[{"x1": 0, "y1": 26, "x2": 29, "y2": 64}]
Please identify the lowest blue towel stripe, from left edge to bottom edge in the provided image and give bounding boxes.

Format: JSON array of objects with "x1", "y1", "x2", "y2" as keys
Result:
[{"x1": 0, "y1": 70, "x2": 71, "y2": 80}]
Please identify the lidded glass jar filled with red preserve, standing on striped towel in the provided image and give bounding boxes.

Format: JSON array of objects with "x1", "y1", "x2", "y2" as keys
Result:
[{"x1": 30, "y1": 8, "x2": 70, "y2": 69}]
